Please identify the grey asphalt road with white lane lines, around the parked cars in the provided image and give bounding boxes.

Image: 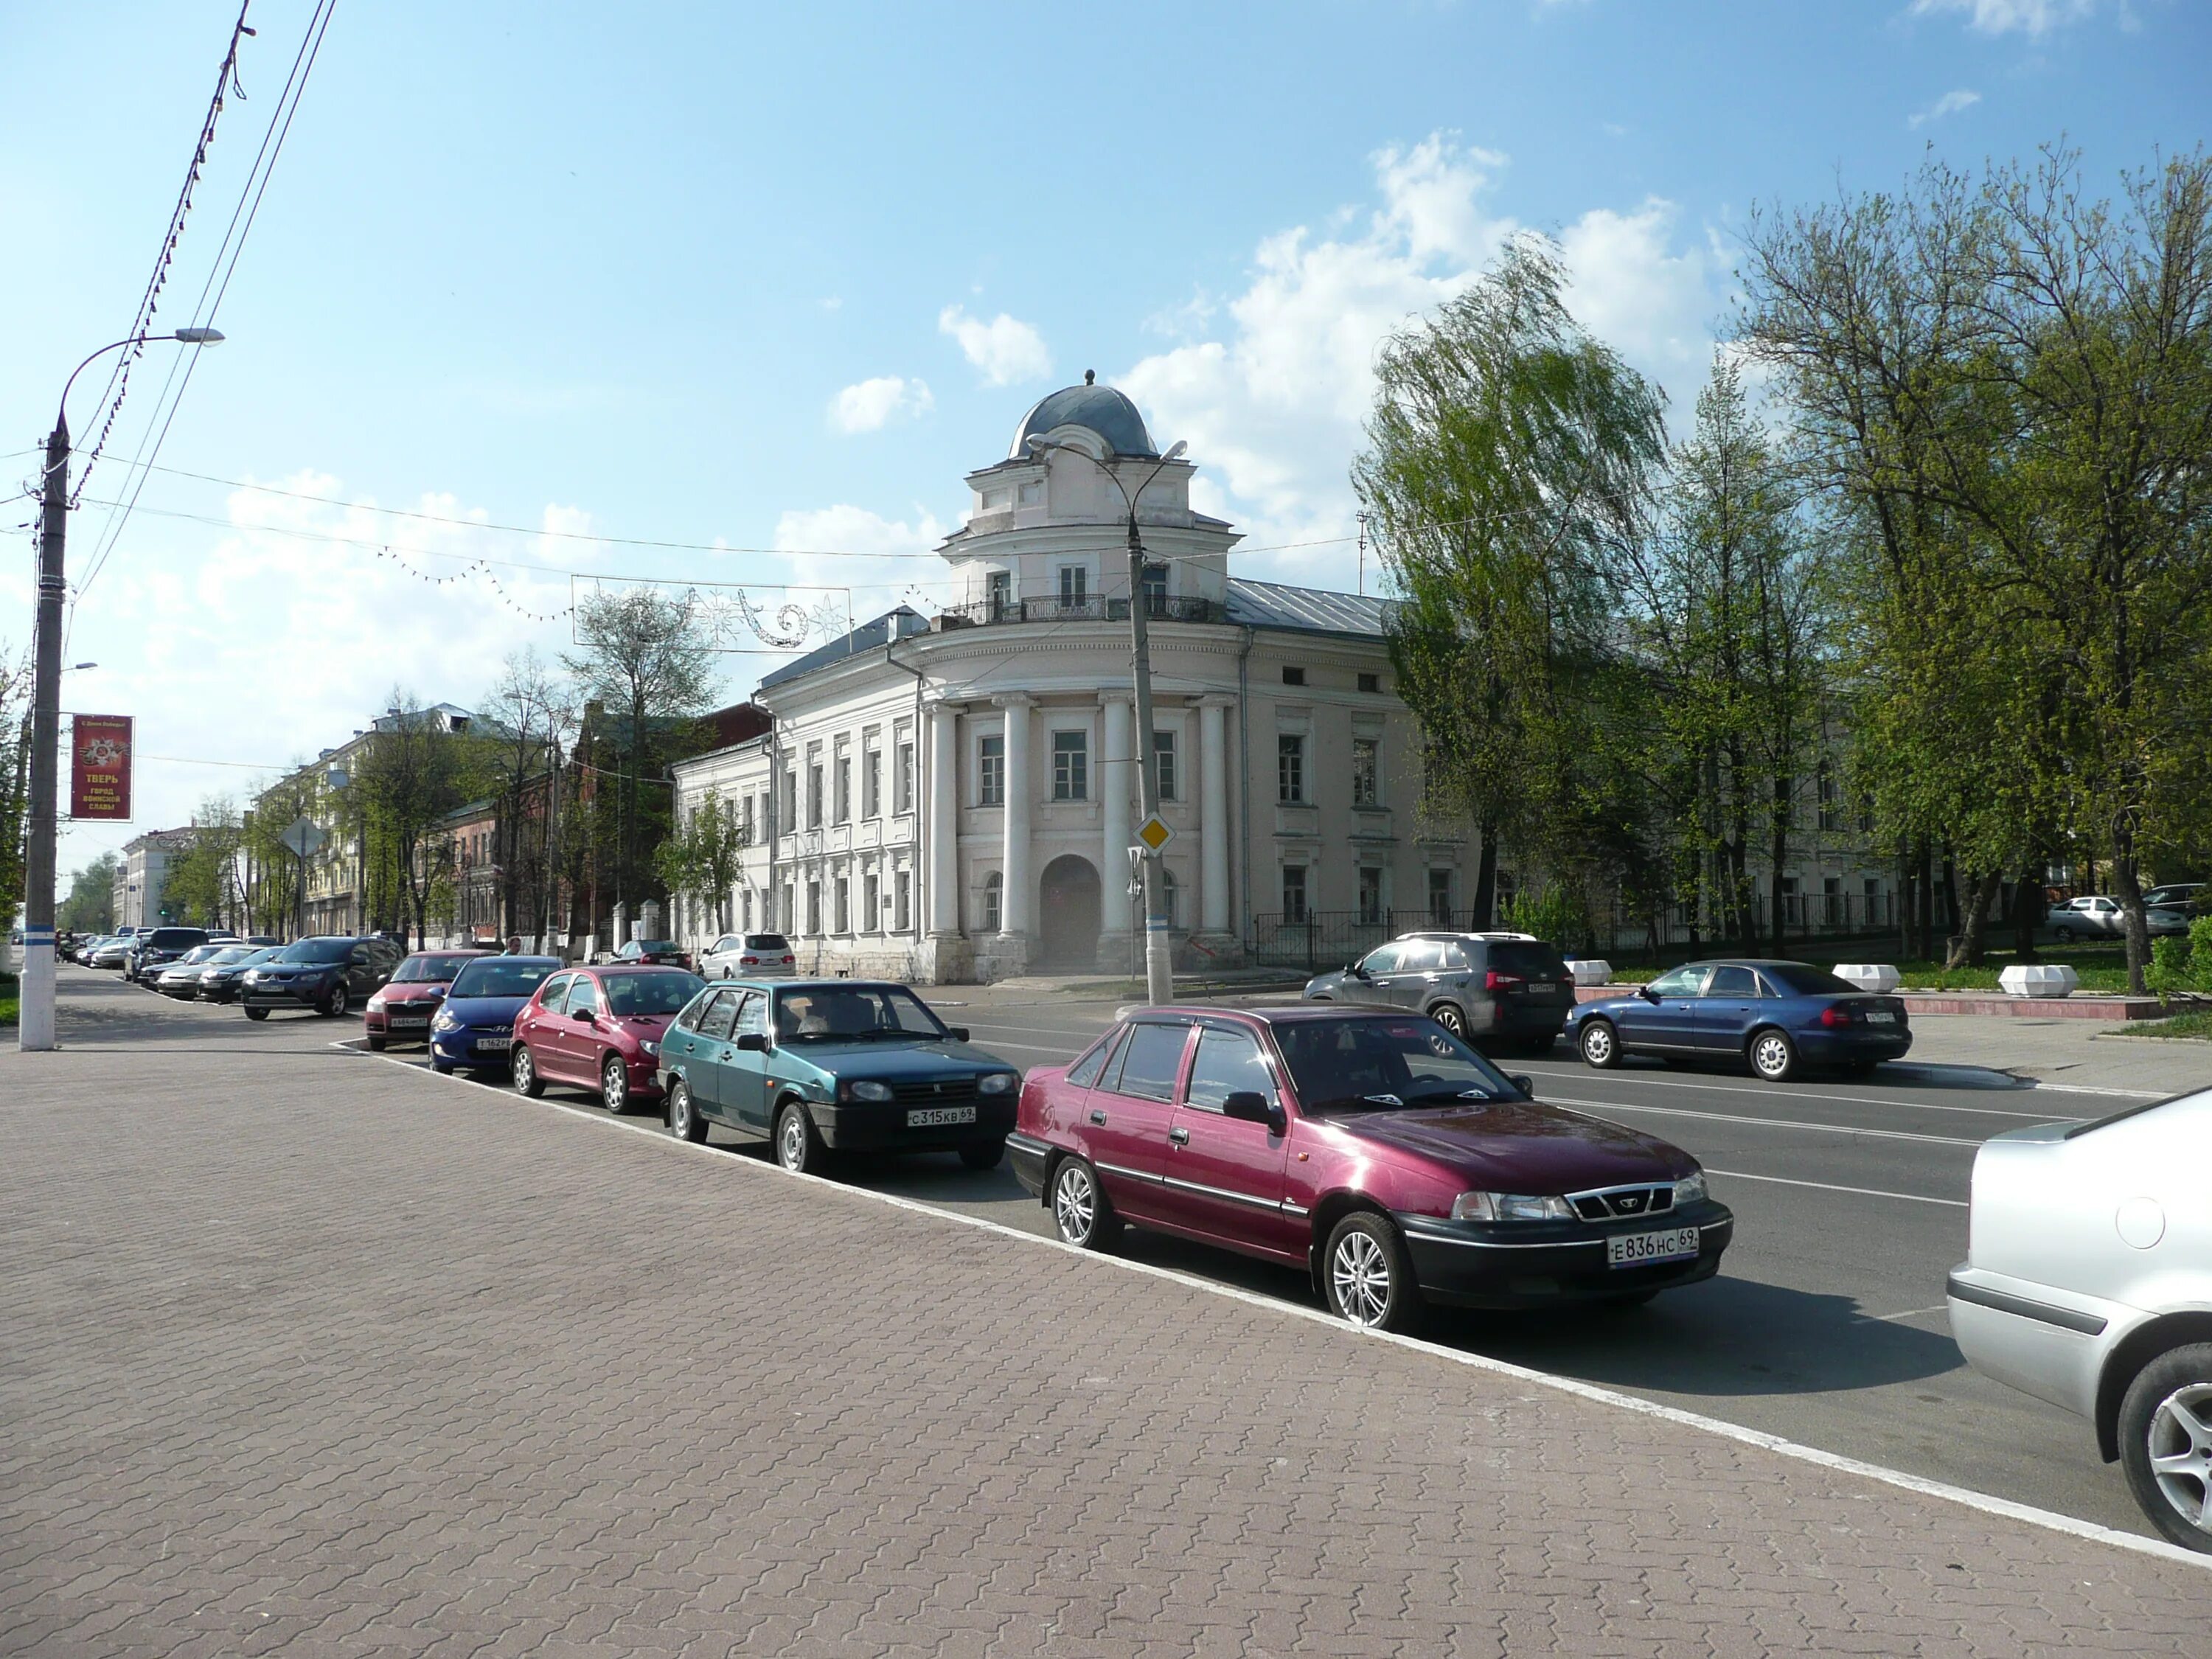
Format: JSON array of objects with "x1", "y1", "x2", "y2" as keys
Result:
[{"x1": 47, "y1": 969, "x2": 2148, "y2": 1557}]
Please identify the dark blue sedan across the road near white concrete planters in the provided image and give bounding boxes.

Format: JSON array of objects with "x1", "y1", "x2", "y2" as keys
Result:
[{"x1": 1566, "y1": 960, "x2": 1913, "y2": 1084}]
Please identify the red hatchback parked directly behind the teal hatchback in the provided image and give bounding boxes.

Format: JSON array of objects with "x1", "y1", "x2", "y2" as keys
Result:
[{"x1": 509, "y1": 967, "x2": 706, "y2": 1113}]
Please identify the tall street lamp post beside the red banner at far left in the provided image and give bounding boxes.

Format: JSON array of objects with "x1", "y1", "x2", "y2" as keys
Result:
[{"x1": 15, "y1": 327, "x2": 223, "y2": 1051}]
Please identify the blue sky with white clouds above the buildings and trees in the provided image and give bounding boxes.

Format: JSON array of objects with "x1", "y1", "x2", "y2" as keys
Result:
[{"x1": 0, "y1": 0, "x2": 2212, "y2": 867}]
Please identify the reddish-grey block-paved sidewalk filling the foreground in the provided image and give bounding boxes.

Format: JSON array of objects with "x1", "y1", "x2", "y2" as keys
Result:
[{"x1": 0, "y1": 1022, "x2": 2212, "y2": 1659}]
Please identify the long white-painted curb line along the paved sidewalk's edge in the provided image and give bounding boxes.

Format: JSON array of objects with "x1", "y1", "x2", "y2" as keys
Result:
[{"x1": 341, "y1": 1051, "x2": 2212, "y2": 1573}]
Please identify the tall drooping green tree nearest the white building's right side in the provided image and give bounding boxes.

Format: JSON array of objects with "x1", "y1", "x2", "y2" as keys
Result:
[{"x1": 1352, "y1": 237, "x2": 1666, "y2": 927}]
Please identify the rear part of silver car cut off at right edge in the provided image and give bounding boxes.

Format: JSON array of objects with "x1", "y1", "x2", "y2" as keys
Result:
[{"x1": 1949, "y1": 1088, "x2": 2212, "y2": 1553}]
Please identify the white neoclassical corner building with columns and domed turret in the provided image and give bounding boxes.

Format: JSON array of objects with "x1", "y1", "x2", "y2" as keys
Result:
[{"x1": 677, "y1": 376, "x2": 1473, "y2": 984}]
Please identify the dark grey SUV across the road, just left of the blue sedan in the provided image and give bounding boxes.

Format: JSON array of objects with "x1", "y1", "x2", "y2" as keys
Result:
[{"x1": 1305, "y1": 931, "x2": 1575, "y2": 1053}]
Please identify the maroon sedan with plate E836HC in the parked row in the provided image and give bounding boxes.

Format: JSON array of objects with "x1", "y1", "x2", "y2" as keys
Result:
[{"x1": 1006, "y1": 1004, "x2": 1734, "y2": 1329}]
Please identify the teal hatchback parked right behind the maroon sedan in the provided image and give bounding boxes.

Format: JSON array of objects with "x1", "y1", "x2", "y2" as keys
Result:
[{"x1": 659, "y1": 980, "x2": 1022, "y2": 1172}]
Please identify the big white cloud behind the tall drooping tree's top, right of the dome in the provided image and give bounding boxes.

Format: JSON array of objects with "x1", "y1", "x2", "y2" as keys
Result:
[{"x1": 1119, "y1": 135, "x2": 1723, "y2": 588}]
